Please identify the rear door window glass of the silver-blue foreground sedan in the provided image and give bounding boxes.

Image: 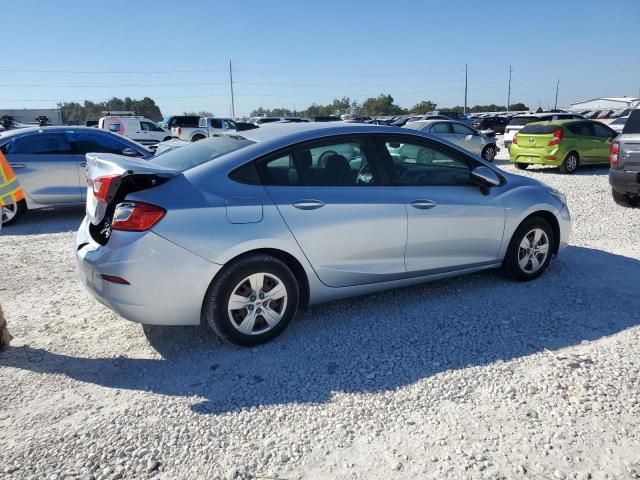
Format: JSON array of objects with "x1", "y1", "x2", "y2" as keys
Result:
[{"x1": 259, "y1": 139, "x2": 379, "y2": 186}]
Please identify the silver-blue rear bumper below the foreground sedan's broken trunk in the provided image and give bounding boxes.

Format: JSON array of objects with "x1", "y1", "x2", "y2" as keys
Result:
[{"x1": 76, "y1": 218, "x2": 222, "y2": 325}]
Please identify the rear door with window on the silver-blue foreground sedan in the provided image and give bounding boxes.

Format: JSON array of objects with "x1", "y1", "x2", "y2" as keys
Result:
[{"x1": 259, "y1": 136, "x2": 407, "y2": 287}]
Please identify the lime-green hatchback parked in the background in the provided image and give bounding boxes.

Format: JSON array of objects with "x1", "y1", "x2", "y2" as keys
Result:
[{"x1": 509, "y1": 120, "x2": 617, "y2": 173}]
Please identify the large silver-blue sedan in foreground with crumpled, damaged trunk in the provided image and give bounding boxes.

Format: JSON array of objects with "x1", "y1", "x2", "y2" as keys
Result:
[{"x1": 76, "y1": 123, "x2": 571, "y2": 345}]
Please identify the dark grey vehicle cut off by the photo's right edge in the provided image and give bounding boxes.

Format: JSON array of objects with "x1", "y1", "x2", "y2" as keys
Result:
[{"x1": 609, "y1": 109, "x2": 640, "y2": 207}]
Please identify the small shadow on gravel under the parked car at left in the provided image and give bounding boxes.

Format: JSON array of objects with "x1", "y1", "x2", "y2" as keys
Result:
[{"x1": 2, "y1": 206, "x2": 84, "y2": 236}]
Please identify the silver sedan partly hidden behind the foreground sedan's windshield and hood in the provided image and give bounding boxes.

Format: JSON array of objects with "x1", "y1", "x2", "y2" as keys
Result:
[{"x1": 404, "y1": 120, "x2": 498, "y2": 162}]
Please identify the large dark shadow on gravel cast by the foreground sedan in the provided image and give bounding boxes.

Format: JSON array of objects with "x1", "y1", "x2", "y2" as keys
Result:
[{"x1": 0, "y1": 247, "x2": 640, "y2": 414}]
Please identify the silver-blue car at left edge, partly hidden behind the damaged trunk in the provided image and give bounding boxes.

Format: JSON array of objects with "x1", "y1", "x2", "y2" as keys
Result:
[{"x1": 0, "y1": 127, "x2": 153, "y2": 225}]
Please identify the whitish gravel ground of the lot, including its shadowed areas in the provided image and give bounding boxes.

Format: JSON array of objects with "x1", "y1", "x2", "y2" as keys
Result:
[{"x1": 0, "y1": 142, "x2": 640, "y2": 479}]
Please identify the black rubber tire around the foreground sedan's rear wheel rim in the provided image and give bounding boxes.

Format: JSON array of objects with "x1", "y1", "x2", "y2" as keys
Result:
[{"x1": 203, "y1": 254, "x2": 299, "y2": 346}]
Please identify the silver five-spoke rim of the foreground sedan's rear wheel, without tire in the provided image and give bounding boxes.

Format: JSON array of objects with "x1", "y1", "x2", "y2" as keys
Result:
[{"x1": 227, "y1": 273, "x2": 288, "y2": 335}]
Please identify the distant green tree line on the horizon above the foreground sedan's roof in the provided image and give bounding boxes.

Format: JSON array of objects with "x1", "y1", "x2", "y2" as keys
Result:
[{"x1": 250, "y1": 94, "x2": 528, "y2": 118}]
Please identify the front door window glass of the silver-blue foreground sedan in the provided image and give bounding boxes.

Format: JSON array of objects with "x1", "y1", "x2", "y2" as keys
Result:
[{"x1": 384, "y1": 138, "x2": 471, "y2": 186}]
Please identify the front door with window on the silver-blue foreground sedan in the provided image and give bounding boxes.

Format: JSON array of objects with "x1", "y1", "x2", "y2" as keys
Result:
[{"x1": 378, "y1": 135, "x2": 505, "y2": 275}]
